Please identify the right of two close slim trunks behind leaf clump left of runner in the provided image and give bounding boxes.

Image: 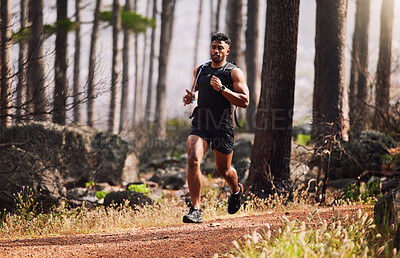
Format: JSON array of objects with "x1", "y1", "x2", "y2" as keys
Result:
[{"x1": 118, "y1": 0, "x2": 131, "y2": 133}]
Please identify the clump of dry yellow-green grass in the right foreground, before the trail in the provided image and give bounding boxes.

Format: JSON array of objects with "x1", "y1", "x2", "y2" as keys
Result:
[{"x1": 220, "y1": 210, "x2": 399, "y2": 257}]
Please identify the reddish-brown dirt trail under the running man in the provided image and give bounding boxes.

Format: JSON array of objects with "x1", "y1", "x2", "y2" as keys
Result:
[{"x1": 0, "y1": 205, "x2": 371, "y2": 258}]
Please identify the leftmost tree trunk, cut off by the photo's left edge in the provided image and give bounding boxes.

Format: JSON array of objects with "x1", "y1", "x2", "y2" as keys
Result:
[{"x1": 0, "y1": 0, "x2": 11, "y2": 133}]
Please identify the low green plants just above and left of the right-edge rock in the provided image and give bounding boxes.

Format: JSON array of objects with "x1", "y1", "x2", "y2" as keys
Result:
[{"x1": 342, "y1": 180, "x2": 381, "y2": 203}]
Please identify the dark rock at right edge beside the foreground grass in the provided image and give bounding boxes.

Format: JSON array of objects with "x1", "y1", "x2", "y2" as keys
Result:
[{"x1": 374, "y1": 188, "x2": 400, "y2": 248}]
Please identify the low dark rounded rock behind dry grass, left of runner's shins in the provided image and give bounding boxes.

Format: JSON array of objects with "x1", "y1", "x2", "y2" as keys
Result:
[{"x1": 103, "y1": 190, "x2": 153, "y2": 208}]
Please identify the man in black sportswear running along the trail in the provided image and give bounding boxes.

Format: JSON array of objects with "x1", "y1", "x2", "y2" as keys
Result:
[{"x1": 183, "y1": 33, "x2": 249, "y2": 223}]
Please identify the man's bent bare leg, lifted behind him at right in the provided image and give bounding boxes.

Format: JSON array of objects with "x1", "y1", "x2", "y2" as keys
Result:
[{"x1": 214, "y1": 150, "x2": 239, "y2": 193}]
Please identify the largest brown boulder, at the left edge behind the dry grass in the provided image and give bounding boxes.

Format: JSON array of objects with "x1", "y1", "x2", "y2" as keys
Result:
[{"x1": 0, "y1": 122, "x2": 139, "y2": 212}]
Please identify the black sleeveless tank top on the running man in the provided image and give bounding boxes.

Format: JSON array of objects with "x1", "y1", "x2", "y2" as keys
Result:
[{"x1": 197, "y1": 63, "x2": 236, "y2": 125}]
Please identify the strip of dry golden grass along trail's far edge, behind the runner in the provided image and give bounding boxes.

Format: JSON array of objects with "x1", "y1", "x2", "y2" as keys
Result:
[{"x1": 0, "y1": 178, "x2": 313, "y2": 239}]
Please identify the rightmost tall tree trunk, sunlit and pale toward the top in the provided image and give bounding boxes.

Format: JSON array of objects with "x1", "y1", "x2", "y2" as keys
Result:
[{"x1": 373, "y1": 0, "x2": 394, "y2": 131}]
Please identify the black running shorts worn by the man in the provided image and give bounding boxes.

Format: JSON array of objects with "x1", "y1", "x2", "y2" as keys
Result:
[{"x1": 189, "y1": 117, "x2": 235, "y2": 154}]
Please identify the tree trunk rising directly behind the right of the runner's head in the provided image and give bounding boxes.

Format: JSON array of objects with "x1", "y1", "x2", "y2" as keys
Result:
[{"x1": 226, "y1": 0, "x2": 243, "y2": 67}]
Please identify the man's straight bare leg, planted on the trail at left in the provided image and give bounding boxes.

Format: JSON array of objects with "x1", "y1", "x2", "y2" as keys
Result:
[{"x1": 187, "y1": 135, "x2": 208, "y2": 209}]
